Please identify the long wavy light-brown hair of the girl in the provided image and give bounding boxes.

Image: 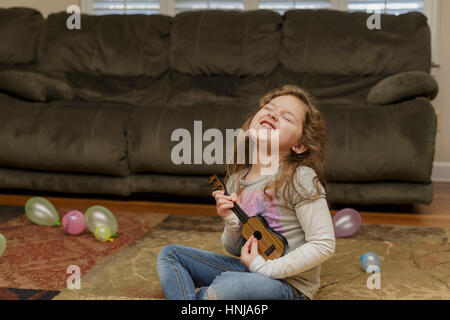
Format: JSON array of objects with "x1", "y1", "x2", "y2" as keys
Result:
[{"x1": 225, "y1": 84, "x2": 327, "y2": 205}]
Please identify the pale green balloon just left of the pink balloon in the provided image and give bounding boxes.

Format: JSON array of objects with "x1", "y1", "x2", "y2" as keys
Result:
[{"x1": 25, "y1": 197, "x2": 60, "y2": 226}]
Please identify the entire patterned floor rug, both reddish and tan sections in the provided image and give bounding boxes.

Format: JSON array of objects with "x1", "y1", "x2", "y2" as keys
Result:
[{"x1": 0, "y1": 207, "x2": 450, "y2": 300}]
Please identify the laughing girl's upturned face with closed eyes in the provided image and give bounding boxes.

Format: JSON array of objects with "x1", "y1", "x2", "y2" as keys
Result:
[{"x1": 249, "y1": 95, "x2": 308, "y2": 156}]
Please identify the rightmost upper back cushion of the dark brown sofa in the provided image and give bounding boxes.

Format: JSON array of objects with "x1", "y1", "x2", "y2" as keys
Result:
[{"x1": 280, "y1": 10, "x2": 431, "y2": 75}]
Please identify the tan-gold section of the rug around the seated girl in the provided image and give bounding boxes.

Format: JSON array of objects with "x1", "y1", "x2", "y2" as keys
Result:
[{"x1": 55, "y1": 215, "x2": 450, "y2": 300}]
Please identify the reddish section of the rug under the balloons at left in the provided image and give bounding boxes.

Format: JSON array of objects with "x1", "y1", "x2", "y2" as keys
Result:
[{"x1": 0, "y1": 206, "x2": 168, "y2": 298}]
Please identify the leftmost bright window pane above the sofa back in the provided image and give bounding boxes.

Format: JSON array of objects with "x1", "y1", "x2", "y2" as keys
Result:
[{"x1": 92, "y1": 0, "x2": 160, "y2": 15}]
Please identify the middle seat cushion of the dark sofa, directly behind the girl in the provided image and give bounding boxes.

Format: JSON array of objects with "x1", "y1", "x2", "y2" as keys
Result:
[{"x1": 128, "y1": 103, "x2": 248, "y2": 175}]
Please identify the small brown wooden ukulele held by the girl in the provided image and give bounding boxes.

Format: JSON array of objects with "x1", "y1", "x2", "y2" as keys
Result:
[{"x1": 209, "y1": 174, "x2": 288, "y2": 260}]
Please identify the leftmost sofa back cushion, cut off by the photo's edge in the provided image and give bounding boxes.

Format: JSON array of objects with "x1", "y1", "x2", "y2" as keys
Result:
[{"x1": 0, "y1": 7, "x2": 44, "y2": 65}]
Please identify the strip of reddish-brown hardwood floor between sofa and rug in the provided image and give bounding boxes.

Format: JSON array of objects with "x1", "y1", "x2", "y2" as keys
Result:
[{"x1": 0, "y1": 182, "x2": 450, "y2": 228}]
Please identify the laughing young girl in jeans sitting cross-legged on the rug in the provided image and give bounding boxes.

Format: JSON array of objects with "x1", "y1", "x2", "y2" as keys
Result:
[{"x1": 157, "y1": 85, "x2": 335, "y2": 300}]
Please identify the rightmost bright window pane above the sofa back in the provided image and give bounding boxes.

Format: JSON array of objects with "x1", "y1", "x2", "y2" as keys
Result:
[{"x1": 348, "y1": 0, "x2": 423, "y2": 15}]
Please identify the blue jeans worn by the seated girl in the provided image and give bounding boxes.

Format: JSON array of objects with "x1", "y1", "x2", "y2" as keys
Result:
[{"x1": 157, "y1": 244, "x2": 309, "y2": 300}]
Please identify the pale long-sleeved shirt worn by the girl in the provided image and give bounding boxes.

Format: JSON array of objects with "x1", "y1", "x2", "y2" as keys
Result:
[{"x1": 222, "y1": 166, "x2": 335, "y2": 299}]
